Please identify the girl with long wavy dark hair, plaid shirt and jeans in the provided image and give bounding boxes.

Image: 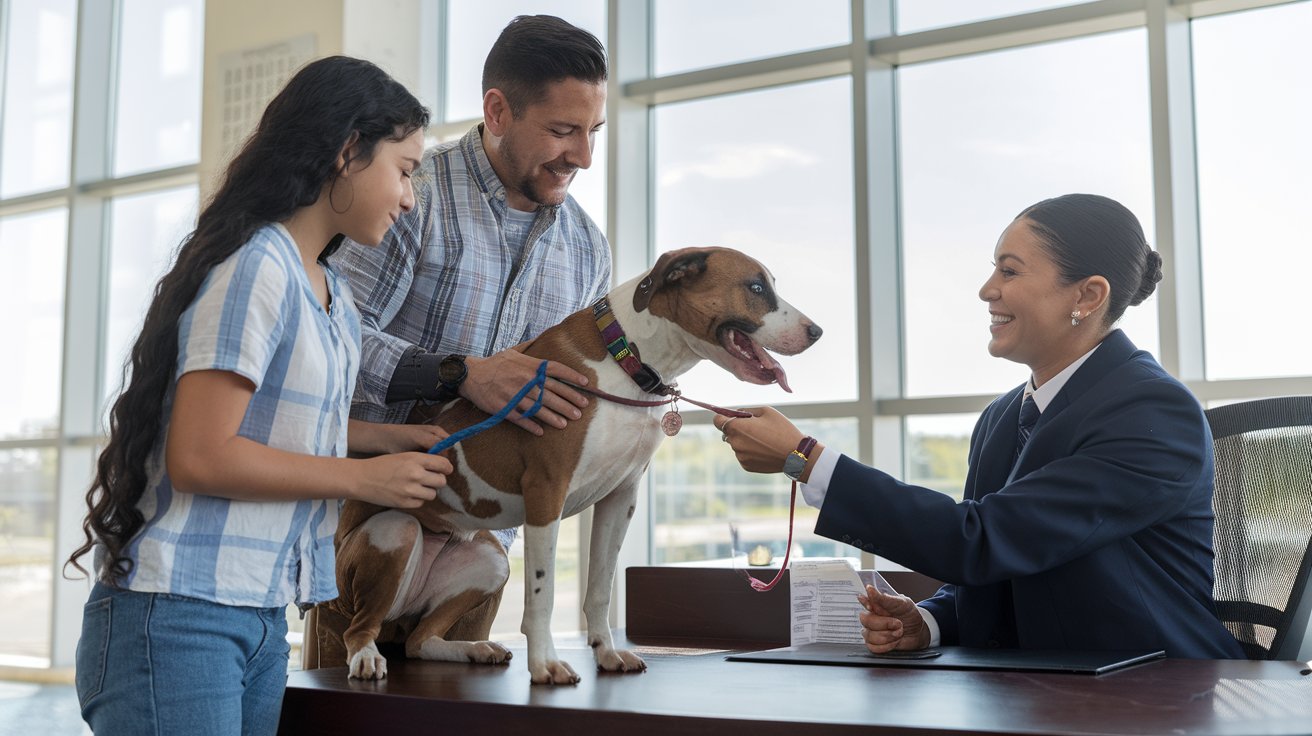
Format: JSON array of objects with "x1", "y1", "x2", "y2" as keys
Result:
[{"x1": 68, "y1": 56, "x2": 451, "y2": 733}]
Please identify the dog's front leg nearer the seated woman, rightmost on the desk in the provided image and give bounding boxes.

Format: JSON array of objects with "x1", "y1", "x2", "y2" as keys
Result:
[{"x1": 583, "y1": 472, "x2": 647, "y2": 672}]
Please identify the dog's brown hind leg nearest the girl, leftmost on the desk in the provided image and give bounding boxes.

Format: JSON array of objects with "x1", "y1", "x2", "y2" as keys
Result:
[{"x1": 337, "y1": 510, "x2": 422, "y2": 680}]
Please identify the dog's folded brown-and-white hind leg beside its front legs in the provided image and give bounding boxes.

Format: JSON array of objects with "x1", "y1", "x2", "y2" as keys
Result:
[{"x1": 405, "y1": 530, "x2": 510, "y2": 664}]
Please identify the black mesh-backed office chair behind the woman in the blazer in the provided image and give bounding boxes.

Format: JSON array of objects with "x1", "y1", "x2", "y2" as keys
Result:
[{"x1": 1206, "y1": 396, "x2": 1312, "y2": 660}]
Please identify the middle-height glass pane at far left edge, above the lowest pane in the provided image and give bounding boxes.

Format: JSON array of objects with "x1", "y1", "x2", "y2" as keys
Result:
[{"x1": 0, "y1": 207, "x2": 68, "y2": 440}]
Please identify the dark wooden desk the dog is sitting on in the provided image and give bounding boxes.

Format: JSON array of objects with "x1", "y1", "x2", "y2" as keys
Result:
[{"x1": 279, "y1": 638, "x2": 1312, "y2": 736}]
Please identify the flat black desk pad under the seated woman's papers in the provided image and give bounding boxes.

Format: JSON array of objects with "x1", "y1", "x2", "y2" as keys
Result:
[{"x1": 724, "y1": 644, "x2": 1166, "y2": 674}]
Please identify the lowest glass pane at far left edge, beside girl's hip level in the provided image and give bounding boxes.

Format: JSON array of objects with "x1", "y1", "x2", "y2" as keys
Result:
[{"x1": 0, "y1": 450, "x2": 58, "y2": 666}]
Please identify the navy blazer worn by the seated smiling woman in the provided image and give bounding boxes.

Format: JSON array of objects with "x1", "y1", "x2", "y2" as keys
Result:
[{"x1": 816, "y1": 329, "x2": 1244, "y2": 659}]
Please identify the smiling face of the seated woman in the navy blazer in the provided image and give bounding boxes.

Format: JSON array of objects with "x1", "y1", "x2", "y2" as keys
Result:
[{"x1": 980, "y1": 218, "x2": 1080, "y2": 375}]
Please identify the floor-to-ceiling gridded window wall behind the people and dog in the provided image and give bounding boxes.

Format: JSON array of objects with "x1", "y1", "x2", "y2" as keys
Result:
[{"x1": 0, "y1": 0, "x2": 1312, "y2": 665}]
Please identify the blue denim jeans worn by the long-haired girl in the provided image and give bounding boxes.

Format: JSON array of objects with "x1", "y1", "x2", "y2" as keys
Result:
[{"x1": 76, "y1": 583, "x2": 290, "y2": 736}]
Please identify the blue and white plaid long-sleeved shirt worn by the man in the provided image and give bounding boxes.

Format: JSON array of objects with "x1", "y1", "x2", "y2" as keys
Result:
[{"x1": 333, "y1": 125, "x2": 610, "y2": 422}]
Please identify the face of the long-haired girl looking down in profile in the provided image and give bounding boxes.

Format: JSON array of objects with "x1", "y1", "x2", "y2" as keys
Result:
[{"x1": 336, "y1": 130, "x2": 424, "y2": 245}]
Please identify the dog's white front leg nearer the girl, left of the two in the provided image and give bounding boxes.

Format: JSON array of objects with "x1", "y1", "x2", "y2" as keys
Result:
[{"x1": 520, "y1": 517, "x2": 579, "y2": 685}]
